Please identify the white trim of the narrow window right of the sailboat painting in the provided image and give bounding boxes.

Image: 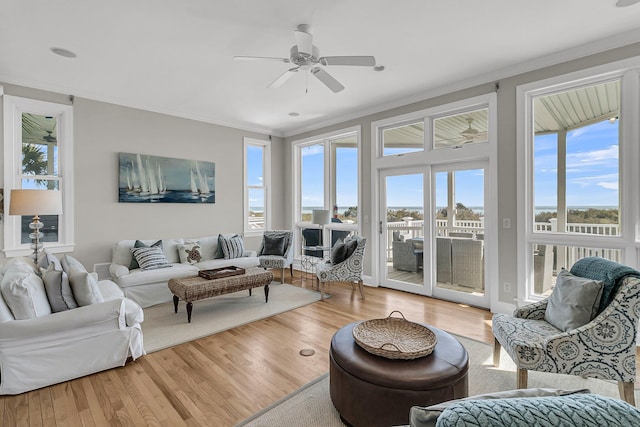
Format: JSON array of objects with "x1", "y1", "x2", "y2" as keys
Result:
[{"x1": 242, "y1": 138, "x2": 271, "y2": 236}]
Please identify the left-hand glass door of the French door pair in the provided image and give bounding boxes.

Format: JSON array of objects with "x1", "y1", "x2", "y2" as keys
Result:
[{"x1": 379, "y1": 168, "x2": 430, "y2": 295}]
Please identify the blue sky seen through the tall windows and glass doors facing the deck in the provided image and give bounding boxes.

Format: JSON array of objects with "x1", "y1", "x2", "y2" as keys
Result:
[{"x1": 302, "y1": 121, "x2": 618, "y2": 211}]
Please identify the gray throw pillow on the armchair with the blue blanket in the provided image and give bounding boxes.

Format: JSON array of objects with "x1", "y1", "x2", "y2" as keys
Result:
[{"x1": 544, "y1": 268, "x2": 604, "y2": 332}]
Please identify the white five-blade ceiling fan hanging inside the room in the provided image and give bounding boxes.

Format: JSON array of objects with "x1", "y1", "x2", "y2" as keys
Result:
[{"x1": 233, "y1": 24, "x2": 376, "y2": 93}]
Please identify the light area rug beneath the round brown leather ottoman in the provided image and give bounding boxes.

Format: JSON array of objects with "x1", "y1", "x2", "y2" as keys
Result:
[{"x1": 237, "y1": 336, "x2": 640, "y2": 427}]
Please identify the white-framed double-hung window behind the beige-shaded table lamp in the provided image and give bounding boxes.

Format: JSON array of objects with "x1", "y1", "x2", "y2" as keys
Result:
[{"x1": 4, "y1": 95, "x2": 73, "y2": 257}]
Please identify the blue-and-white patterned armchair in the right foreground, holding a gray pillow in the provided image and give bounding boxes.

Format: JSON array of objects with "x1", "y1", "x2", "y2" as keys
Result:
[{"x1": 493, "y1": 261, "x2": 640, "y2": 405}]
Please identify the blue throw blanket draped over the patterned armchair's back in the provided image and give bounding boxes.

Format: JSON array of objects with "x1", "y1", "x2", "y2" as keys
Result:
[{"x1": 571, "y1": 257, "x2": 640, "y2": 313}]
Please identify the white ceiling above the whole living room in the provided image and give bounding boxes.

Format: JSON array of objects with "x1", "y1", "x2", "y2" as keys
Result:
[{"x1": 0, "y1": 0, "x2": 640, "y2": 136}]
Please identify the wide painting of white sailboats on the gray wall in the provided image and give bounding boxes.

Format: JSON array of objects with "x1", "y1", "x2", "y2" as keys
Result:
[{"x1": 118, "y1": 153, "x2": 216, "y2": 203}]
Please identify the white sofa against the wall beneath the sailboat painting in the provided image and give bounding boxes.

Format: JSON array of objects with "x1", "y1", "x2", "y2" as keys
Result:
[{"x1": 109, "y1": 234, "x2": 260, "y2": 308}]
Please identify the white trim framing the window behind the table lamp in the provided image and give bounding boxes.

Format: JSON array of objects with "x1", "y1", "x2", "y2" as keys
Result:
[{"x1": 3, "y1": 95, "x2": 75, "y2": 257}]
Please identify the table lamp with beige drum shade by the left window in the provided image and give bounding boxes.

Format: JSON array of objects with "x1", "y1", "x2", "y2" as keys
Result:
[{"x1": 9, "y1": 189, "x2": 62, "y2": 265}]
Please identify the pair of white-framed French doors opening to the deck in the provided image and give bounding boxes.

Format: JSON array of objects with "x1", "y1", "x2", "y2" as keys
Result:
[{"x1": 378, "y1": 162, "x2": 491, "y2": 307}]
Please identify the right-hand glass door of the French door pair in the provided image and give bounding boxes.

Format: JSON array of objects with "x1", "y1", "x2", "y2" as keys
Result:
[{"x1": 431, "y1": 165, "x2": 489, "y2": 307}]
